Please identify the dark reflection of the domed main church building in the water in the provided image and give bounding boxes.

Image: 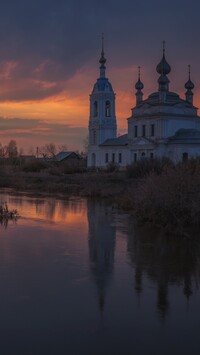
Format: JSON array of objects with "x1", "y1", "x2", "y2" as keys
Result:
[{"x1": 127, "y1": 228, "x2": 200, "y2": 318}]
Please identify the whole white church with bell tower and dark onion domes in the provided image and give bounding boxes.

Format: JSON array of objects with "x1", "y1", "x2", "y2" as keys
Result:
[{"x1": 88, "y1": 41, "x2": 200, "y2": 168}]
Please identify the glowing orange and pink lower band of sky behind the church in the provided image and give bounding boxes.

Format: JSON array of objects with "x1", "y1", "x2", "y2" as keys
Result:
[{"x1": 0, "y1": 57, "x2": 200, "y2": 153}]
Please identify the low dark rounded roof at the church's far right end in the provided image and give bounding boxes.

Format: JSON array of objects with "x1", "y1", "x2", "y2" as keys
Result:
[{"x1": 168, "y1": 128, "x2": 200, "y2": 144}]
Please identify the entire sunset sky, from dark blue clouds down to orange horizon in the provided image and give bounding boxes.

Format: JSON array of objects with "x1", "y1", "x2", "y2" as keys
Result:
[{"x1": 0, "y1": 0, "x2": 200, "y2": 153}]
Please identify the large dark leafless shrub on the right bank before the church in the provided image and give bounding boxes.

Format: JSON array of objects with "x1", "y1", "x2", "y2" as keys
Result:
[{"x1": 132, "y1": 159, "x2": 200, "y2": 235}]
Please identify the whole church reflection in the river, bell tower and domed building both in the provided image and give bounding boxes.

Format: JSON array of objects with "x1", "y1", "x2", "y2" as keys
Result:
[{"x1": 88, "y1": 200, "x2": 200, "y2": 318}]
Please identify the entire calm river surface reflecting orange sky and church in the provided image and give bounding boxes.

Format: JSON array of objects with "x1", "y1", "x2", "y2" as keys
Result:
[{"x1": 0, "y1": 194, "x2": 200, "y2": 355}]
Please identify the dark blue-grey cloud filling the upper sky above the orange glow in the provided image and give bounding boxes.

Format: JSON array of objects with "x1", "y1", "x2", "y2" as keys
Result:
[{"x1": 0, "y1": 0, "x2": 200, "y2": 100}]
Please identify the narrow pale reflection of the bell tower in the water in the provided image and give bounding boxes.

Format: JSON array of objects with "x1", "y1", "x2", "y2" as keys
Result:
[{"x1": 88, "y1": 200, "x2": 116, "y2": 313}]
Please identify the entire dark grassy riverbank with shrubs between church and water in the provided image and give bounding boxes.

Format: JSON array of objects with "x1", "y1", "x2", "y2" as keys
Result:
[{"x1": 0, "y1": 159, "x2": 200, "y2": 237}]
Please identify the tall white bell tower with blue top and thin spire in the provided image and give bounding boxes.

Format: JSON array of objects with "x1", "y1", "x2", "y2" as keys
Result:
[{"x1": 88, "y1": 36, "x2": 117, "y2": 167}]
